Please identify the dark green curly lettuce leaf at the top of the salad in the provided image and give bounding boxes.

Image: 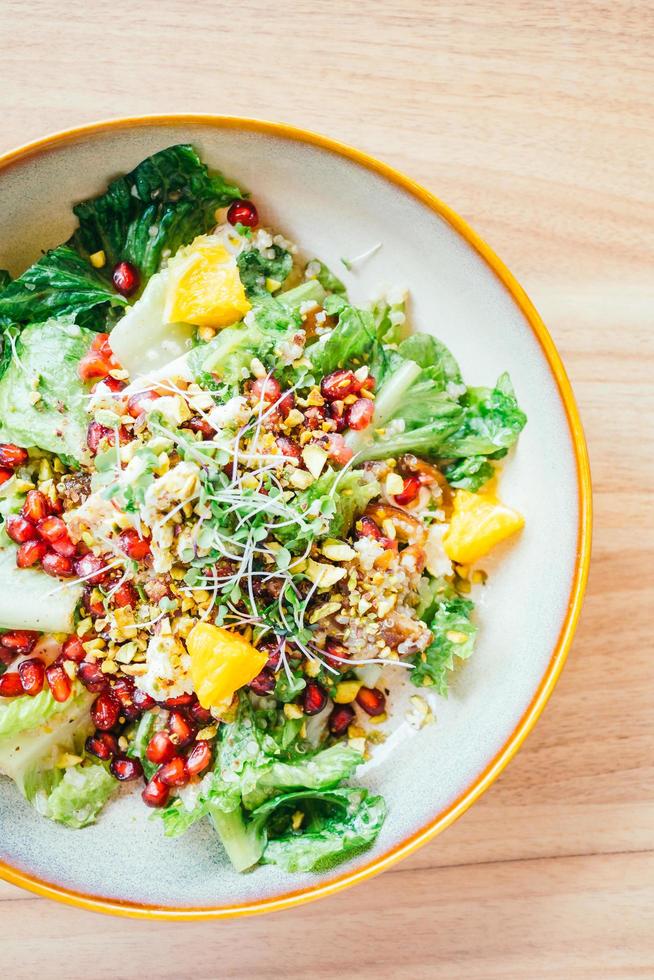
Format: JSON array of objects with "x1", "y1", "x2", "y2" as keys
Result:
[{"x1": 71, "y1": 144, "x2": 242, "y2": 284}]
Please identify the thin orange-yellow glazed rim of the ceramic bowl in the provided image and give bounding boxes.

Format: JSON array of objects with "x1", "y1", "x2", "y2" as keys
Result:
[{"x1": 0, "y1": 113, "x2": 592, "y2": 920}]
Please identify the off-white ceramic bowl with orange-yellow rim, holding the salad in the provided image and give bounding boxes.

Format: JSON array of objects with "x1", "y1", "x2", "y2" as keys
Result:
[{"x1": 0, "y1": 116, "x2": 590, "y2": 917}]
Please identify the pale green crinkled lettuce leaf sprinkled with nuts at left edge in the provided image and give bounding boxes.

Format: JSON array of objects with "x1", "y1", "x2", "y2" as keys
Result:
[{"x1": 0, "y1": 318, "x2": 93, "y2": 460}]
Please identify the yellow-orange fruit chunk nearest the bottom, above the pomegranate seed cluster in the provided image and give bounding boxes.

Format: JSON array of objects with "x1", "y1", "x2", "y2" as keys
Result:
[{"x1": 186, "y1": 623, "x2": 268, "y2": 708}]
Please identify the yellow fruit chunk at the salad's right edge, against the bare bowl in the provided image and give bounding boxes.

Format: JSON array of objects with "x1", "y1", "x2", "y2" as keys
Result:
[{"x1": 443, "y1": 490, "x2": 525, "y2": 565}]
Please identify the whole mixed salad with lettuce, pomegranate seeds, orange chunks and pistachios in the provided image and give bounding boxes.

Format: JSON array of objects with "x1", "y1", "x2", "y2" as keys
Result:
[{"x1": 0, "y1": 145, "x2": 526, "y2": 872}]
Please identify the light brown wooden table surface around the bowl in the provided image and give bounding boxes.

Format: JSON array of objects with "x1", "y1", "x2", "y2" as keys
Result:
[{"x1": 0, "y1": 0, "x2": 654, "y2": 980}]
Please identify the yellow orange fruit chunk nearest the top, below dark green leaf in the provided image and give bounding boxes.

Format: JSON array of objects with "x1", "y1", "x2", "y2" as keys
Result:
[{"x1": 164, "y1": 235, "x2": 250, "y2": 328}]
